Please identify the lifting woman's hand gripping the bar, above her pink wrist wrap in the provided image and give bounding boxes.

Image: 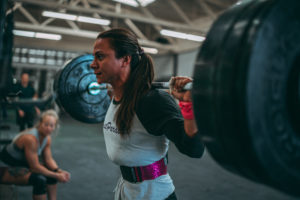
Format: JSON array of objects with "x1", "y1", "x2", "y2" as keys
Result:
[{"x1": 170, "y1": 76, "x2": 192, "y2": 102}]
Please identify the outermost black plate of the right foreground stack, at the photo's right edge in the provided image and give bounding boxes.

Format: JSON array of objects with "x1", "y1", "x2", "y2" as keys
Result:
[{"x1": 245, "y1": 0, "x2": 300, "y2": 196}]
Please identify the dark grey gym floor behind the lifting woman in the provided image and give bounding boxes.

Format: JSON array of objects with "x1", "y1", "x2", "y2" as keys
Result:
[{"x1": 0, "y1": 109, "x2": 297, "y2": 200}]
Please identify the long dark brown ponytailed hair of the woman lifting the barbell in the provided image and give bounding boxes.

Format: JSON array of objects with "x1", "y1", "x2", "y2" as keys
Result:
[{"x1": 97, "y1": 28, "x2": 154, "y2": 136}]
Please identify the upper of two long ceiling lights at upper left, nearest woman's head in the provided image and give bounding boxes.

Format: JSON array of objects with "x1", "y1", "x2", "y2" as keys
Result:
[{"x1": 42, "y1": 11, "x2": 110, "y2": 26}]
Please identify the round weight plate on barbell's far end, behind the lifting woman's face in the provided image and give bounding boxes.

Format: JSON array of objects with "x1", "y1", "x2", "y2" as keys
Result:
[{"x1": 54, "y1": 54, "x2": 110, "y2": 123}]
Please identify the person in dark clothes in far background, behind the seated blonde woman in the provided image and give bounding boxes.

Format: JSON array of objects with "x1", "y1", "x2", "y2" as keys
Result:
[{"x1": 14, "y1": 73, "x2": 40, "y2": 131}]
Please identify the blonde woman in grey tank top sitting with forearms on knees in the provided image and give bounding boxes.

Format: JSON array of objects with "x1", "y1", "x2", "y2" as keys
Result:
[{"x1": 0, "y1": 110, "x2": 70, "y2": 200}]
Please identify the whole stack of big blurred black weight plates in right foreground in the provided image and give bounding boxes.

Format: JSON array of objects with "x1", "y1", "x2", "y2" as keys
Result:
[{"x1": 193, "y1": 0, "x2": 300, "y2": 195}]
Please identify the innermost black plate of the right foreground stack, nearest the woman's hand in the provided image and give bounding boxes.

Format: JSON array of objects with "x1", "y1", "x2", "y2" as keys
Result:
[{"x1": 192, "y1": 2, "x2": 253, "y2": 168}]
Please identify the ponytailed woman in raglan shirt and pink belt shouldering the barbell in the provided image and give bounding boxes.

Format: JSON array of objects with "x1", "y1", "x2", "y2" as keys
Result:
[{"x1": 91, "y1": 28, "x2": 204, "y2": 200}]
